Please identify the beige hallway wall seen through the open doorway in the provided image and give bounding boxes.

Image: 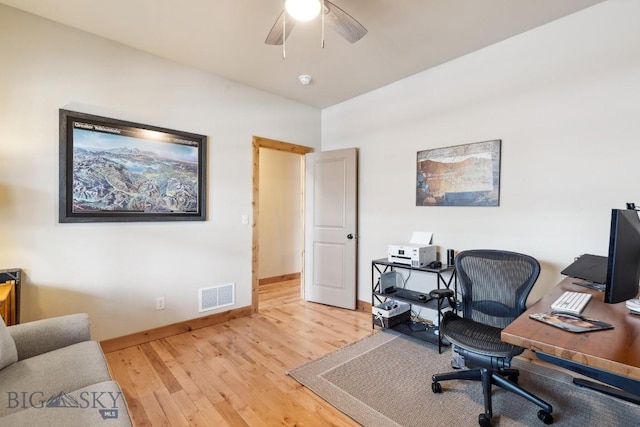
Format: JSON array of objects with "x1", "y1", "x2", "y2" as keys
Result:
[{"x1": 258, "y1": 148, "x2": 303, "y2": 279}]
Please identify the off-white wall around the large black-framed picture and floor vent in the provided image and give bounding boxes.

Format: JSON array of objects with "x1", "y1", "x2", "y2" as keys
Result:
[{"x1": 0, "y1": 6, "x2": 320, "y2": 339}]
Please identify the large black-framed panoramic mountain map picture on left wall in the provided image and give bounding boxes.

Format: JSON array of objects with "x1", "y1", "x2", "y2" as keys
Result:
[{"x1": 59, "y1": 109, "x2": 207, "y2": 223}]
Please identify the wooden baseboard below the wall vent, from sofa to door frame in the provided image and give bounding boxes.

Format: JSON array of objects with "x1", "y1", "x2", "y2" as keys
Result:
[{"x1": 100, "y1": 306, "x2": 251, "y2": 353}]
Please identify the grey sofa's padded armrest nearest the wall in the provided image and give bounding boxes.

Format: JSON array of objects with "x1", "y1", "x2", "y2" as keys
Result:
[{"x1": 7, "y1": 313, "x2": 91, "y2": 360}]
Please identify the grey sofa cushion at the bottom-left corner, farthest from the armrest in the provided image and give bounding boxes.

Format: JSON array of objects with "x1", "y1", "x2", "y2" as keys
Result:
[{"x1": 0, "y1": 381, "x2": 131, "y2": 427}]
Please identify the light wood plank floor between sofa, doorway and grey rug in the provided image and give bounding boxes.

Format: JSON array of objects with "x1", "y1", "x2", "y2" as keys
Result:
[{"x1": 106, "y1": 281, "x2": 372, "y2": 427}]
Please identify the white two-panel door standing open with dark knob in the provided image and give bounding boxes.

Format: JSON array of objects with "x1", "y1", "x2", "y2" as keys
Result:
[{"x1": 304, "y1": 148, "x2": 358, "y2": 310}]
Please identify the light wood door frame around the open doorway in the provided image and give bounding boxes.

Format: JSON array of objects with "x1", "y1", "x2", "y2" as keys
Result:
[{"x1": 251, "y1": 136, "x2": 314, "y2": 313}]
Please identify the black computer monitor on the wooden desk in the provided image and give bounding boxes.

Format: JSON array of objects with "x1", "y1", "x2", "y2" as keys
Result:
[{"x1": 604, "y1": 209, "x2": 640, "y2": 304}]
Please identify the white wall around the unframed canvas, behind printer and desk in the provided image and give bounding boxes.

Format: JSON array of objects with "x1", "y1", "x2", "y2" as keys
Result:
[{"x1": 322, "y1": 0, "x2": 640, "y2": 301}]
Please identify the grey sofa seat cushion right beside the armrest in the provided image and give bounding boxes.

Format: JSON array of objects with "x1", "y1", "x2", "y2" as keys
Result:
[{"x1": 0, "y1": 341, "x2": 111, "y2": 417}]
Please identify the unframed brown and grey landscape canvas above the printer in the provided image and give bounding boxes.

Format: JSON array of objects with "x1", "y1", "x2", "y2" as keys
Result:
[{"x1": 416, "y1": 139, "x2": 501, "y2": 206}]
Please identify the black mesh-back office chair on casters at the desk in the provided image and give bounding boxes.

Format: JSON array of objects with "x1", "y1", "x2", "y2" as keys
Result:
[{"x1": 431, "y1": 250, "x2": 553, "y2": 427}]
